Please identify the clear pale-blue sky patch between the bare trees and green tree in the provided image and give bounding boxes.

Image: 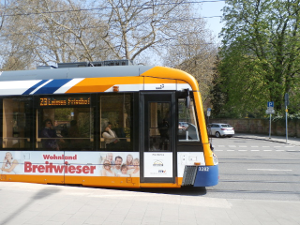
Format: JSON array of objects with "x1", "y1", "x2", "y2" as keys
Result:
[{"x1": 200, "y1": 0, "x2": 225, "y2": 42}]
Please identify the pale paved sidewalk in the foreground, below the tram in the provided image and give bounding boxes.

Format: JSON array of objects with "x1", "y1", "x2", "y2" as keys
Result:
[{"x1": 0, "y1": 182, "x2": 300, "y2": 225}]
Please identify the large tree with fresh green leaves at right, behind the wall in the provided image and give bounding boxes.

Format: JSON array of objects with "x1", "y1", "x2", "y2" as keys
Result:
[{"x1": 219, "y1": 0, "x2": 300, "y2": 113}]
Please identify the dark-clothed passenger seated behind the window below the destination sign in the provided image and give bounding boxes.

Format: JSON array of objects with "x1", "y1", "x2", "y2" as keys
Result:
[{"x1": 40, "y1": 119, "x2": 59, "y2": 150}]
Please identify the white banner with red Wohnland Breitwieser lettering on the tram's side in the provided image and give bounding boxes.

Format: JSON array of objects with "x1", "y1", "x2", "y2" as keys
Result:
[{"x1": 0, "y1": 151, "x2": 140, "y2": 177}]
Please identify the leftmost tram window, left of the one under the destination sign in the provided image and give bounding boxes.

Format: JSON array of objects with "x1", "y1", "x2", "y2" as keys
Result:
[{"x1": 2, "y1": 97, "x2": 31, "y2": 149}]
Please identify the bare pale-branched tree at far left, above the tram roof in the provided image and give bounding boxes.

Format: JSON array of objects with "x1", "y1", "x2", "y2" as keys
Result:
[{"x1": 3, "y1": 0, "x2": 107, "y2": 65}]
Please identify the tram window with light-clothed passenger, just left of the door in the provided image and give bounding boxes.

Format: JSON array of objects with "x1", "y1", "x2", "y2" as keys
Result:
[{"x1": 100, "y1": 94, "x2": 132, "y2": 151}]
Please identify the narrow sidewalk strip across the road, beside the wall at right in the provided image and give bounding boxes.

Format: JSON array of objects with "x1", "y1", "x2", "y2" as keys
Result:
[{"x1": 234, "y1": 134, "x2": 300, "y2": 146}]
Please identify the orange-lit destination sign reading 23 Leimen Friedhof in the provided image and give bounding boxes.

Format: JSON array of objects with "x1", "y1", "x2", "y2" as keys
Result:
[{"x1": 40, "y1": 97, "x2": 90, "y2": 106}]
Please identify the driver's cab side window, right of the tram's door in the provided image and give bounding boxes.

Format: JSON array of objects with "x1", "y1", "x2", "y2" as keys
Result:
[{"x1": 178, "y1": 99, "x2": 200, "y2": 141}]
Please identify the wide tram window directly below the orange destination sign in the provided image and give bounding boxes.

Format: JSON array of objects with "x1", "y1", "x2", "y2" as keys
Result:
[{"x1": 37, "y1": 96, "x2": 94, "y2": 151}]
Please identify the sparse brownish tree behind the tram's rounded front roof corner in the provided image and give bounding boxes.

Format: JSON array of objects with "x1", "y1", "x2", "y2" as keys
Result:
[{"x1": 163, "y1": 9, "x2": 217, "y2": 102}]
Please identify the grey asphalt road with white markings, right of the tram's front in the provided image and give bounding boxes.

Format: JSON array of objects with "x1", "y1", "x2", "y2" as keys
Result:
[{"x1": 207, "y1": 138, "x2": 300, "y2": 201}]
